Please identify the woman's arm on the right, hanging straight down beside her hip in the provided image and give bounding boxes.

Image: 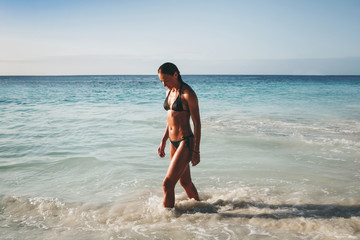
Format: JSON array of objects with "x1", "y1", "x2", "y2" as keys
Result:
[{"x1": 187, "y1": 91, "x2": 201, "y2": 166}]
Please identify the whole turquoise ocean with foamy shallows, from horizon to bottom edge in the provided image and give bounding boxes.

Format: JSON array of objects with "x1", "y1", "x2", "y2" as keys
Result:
[{"x1": 0, "y1": 75, "x2": 360, "y2": 240}]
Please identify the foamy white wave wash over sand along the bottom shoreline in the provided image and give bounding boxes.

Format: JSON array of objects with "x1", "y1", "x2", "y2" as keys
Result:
[{"x1": 0, "y1": 188, "x2": 360, "y2": 240}]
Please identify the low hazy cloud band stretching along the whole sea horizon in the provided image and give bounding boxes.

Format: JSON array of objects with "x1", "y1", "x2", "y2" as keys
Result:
[{"x1": 0, "y1": 55, "x2": 360, "y2": 75}]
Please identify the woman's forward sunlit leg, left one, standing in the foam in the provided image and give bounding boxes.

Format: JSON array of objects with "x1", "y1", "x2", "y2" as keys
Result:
[{"x1": 163, "y1": 141, "x2": 191, "y2": 208}]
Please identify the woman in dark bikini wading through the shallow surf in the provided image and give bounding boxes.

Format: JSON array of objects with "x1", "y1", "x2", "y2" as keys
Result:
[{"x1": 158, "y1": 63, "x2": 201, "y2": 208}]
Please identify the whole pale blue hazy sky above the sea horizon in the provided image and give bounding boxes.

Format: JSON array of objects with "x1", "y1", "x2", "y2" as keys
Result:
[{"x1": 0, "y1": 0, "x2": 360, "y2": 75}]
